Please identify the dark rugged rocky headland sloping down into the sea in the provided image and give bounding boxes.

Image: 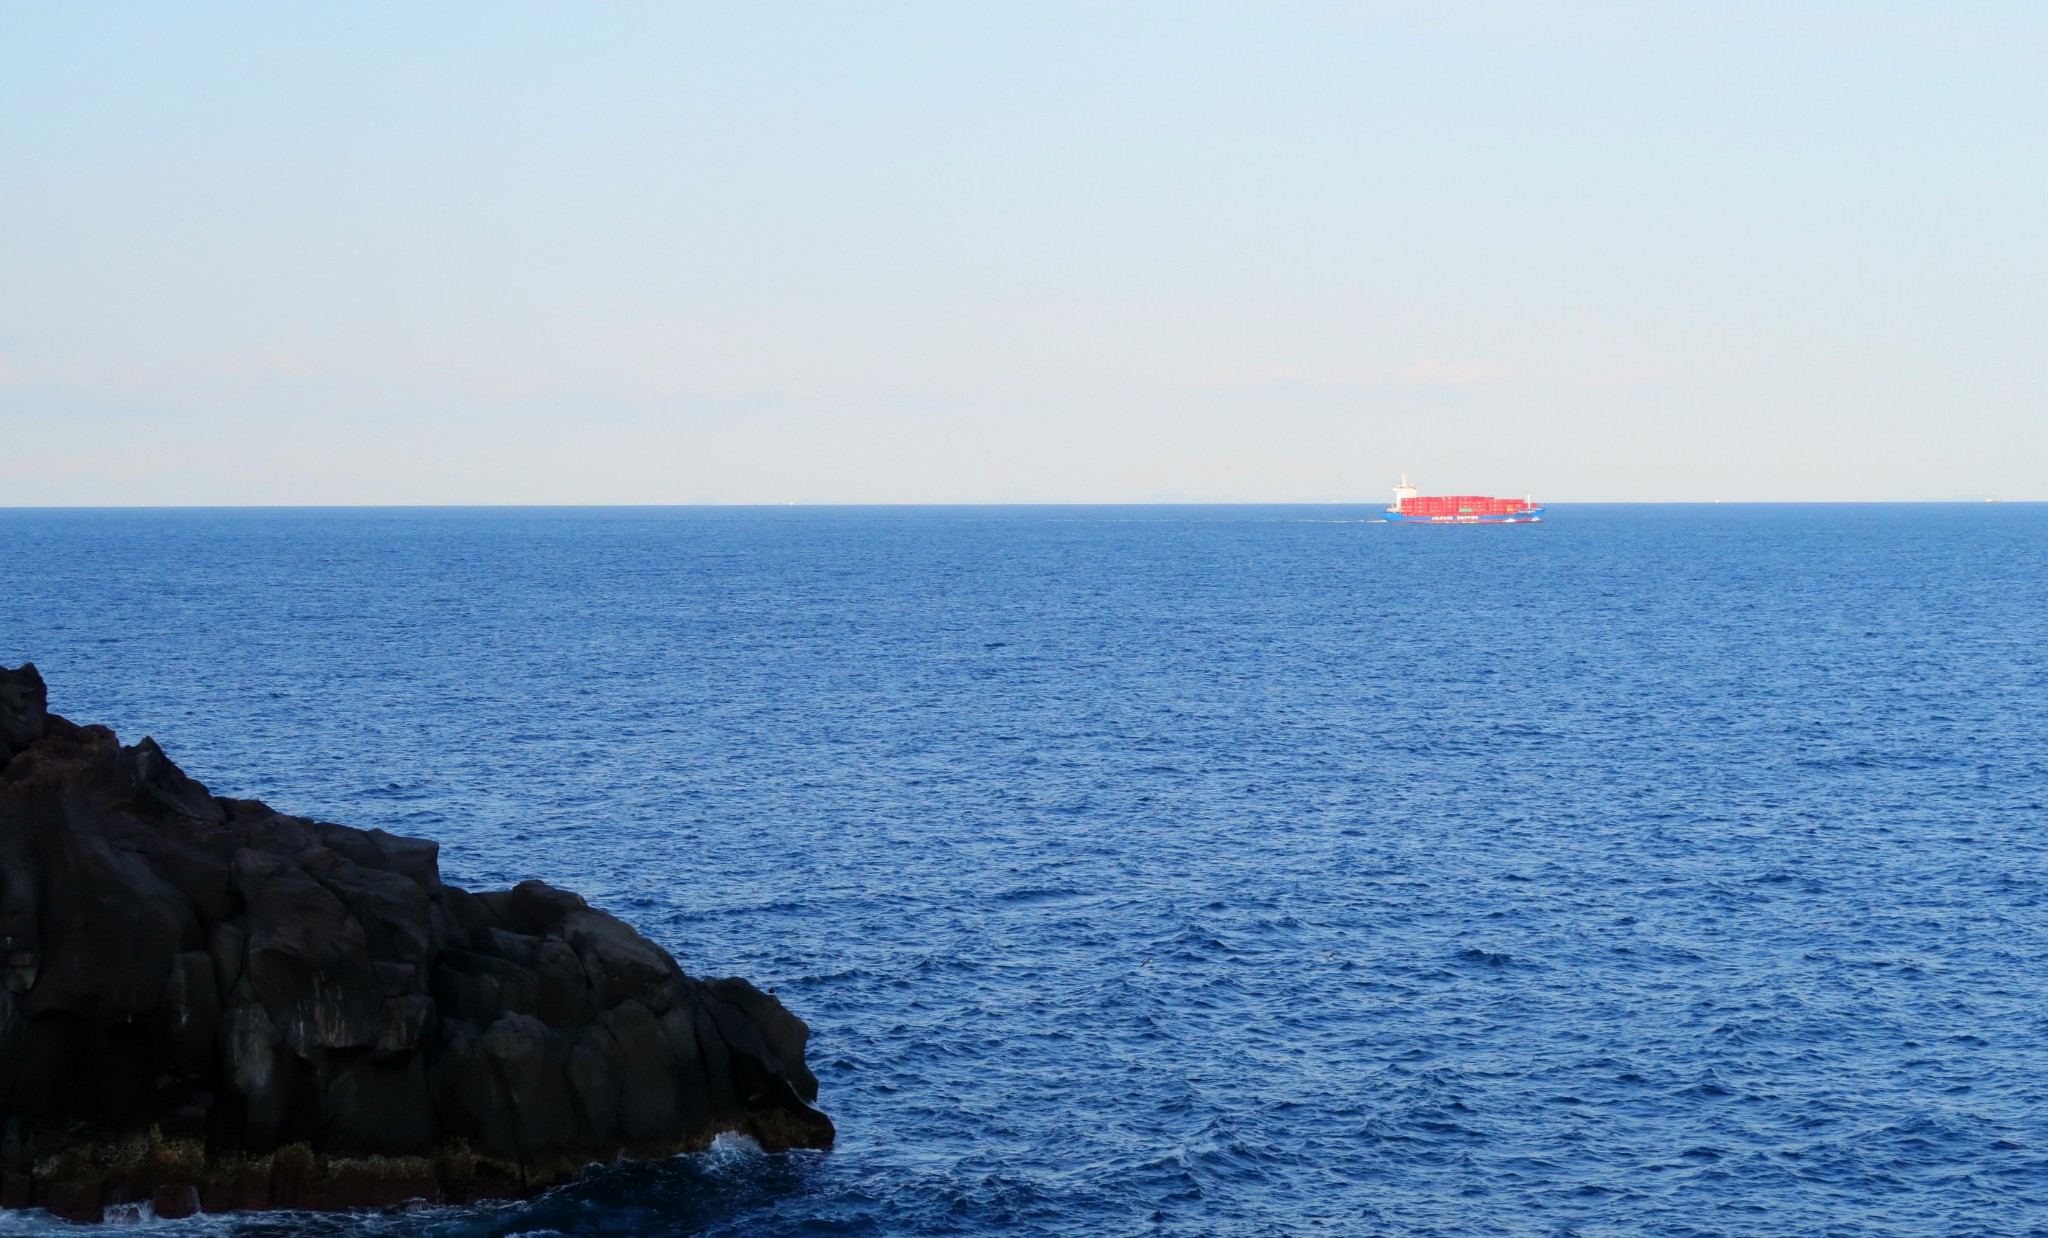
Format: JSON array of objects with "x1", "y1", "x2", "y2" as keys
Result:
[{"x1": 0, "y1": 666, "x2": 834, "y2": 1220}]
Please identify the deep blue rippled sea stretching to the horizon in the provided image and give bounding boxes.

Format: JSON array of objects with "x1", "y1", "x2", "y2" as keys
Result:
[{"x1": 0, "y1": 504, "x2": 2048, "y2": 1238}]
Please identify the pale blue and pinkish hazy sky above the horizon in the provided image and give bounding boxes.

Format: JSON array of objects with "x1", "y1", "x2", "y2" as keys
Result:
[{"x1": 0, "y1": 0, "x2": 2048, "y2": 506}]
